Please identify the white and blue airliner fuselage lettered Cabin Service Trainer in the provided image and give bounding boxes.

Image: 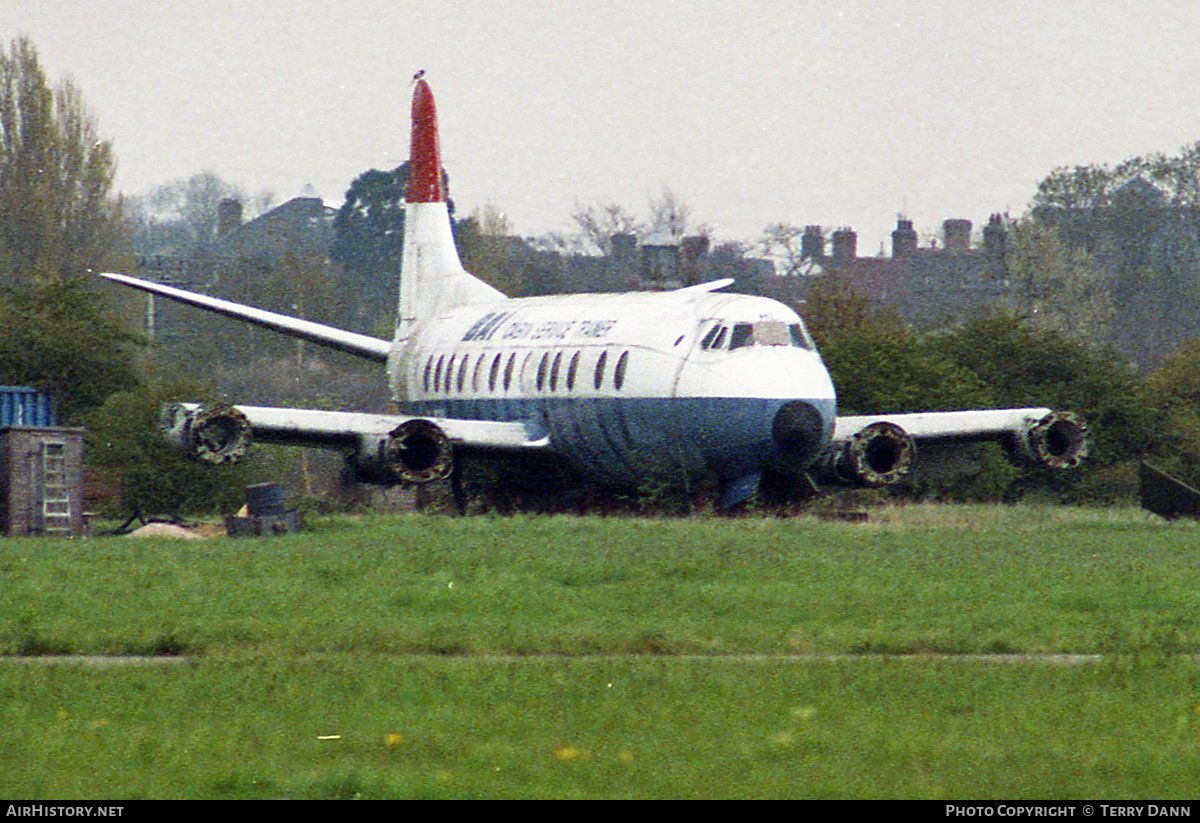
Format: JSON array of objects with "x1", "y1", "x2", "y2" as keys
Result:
[{"x1": 389, "y1": 289, "x2": 836, "y2": 483}]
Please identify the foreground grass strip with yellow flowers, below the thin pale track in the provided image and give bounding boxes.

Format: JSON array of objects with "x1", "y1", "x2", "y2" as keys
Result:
[{"x1": 0, "y1": 657, "x2": 1200, "y2": 799}]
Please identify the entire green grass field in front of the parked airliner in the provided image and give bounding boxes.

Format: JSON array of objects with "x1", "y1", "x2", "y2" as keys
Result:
[{"x1": 0, "y1": 506, "x2": 1200, "y2": 798}]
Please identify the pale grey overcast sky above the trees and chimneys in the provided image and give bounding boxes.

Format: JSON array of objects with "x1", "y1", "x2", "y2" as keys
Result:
[{"x1": 0, "y1": 0, "x2": 1200, "y2": 254}]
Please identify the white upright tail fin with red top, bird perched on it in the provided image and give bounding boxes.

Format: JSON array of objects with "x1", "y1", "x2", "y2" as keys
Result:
[{"x1": 396, "y1": 78, "x2": 505, "y2": 341}]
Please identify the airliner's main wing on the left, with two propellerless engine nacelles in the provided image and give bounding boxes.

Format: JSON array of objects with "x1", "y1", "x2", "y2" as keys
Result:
[{"x1": 162, "y1": 403, "x2": 550, "y2": 482}]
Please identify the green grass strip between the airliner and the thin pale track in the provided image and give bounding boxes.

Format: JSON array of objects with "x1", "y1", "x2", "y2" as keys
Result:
[{"x1": 0, "y1": 506, "x2": 1200, "y2": 657}]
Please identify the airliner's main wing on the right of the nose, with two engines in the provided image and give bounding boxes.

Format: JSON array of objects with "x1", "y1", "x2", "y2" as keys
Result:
[{"x1": 818, "y1": 408, "x2": 1090, "y2": 486}]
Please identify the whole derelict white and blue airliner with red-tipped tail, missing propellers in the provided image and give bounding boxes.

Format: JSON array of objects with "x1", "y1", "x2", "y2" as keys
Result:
[{"x1": 102, "y1": 77, "x2": 1088, "y2": 507}]
